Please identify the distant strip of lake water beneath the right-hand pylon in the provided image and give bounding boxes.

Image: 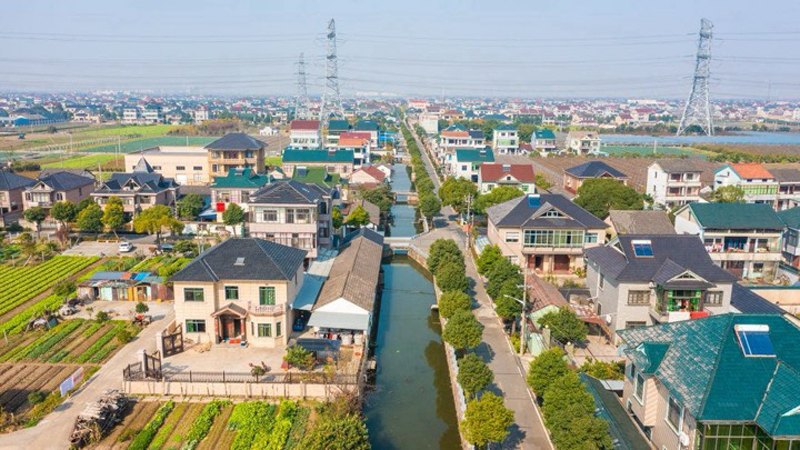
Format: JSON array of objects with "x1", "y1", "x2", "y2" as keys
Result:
[{"x1": 600, "y1": 131, "x2": 800, "y2": 145}]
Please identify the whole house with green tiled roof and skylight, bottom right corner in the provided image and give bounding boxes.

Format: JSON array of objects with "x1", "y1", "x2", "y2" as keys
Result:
[{"x1": 619, "y1": 314, "x2": 800, "y2": 450}]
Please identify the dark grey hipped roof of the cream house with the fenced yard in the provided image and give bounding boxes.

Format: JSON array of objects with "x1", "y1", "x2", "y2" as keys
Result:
[{"x1": 171, "y1": 238, "x2": 307, "y2": 281}]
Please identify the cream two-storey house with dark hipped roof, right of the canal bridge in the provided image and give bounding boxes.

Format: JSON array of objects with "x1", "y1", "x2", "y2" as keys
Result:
[{"x1": 486, "y1": 194, "x2": 606, "y2": 277}]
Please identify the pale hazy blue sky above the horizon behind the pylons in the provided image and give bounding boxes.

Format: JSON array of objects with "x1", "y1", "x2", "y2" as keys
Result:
[{"x1": 0, "y1": 0, "x2": 800, "y2": 100}]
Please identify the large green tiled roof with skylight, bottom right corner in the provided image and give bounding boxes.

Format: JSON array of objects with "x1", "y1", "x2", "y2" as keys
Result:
[{"x1": 618, "y1": 314, "x2": 800, "y2": 436}]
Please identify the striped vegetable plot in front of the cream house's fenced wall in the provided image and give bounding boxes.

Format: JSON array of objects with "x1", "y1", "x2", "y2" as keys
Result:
[{"x1": 95, "y1": 400, "x2": 311, "y2": 450}]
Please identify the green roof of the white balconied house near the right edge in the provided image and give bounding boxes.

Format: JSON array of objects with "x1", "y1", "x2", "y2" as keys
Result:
[{"x1": 689, "y1": 203, "x2": 784, "y2": 230}]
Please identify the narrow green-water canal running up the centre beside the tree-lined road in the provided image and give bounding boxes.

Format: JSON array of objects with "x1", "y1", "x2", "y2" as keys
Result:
[{"x1": 364, "y1": 164, "x2": 460, "y2": 450}]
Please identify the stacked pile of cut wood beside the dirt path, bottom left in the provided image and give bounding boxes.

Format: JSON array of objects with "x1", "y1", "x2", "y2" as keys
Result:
[{"x1": 70, "y1": 389, "x2": 130, "y2": 448}]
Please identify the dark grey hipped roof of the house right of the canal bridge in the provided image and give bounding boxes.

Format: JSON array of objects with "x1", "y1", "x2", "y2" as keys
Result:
[{"x1": 486, "y1": 194, "x2": 608, "y2": 229}]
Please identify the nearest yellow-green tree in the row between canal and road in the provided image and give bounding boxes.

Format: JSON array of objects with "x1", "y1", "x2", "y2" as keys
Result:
[{"x1": 462, "y1": 392, "x2": 514, "y2": 447}]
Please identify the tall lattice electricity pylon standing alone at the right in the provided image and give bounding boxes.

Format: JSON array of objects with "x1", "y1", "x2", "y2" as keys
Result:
[{"x1": 677, "y1": 19, "x2": 714, "y2": 136}]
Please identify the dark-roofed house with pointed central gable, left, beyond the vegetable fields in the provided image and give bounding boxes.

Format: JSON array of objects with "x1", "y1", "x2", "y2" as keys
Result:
[{"x1": 90, "y1": 159, "x2": 180, "y2": 215}]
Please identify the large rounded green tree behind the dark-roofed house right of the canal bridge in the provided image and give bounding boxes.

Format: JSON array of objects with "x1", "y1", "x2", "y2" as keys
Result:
[{"x1": 574, "y1": 178, "x2": 644, "y2": 219}]
